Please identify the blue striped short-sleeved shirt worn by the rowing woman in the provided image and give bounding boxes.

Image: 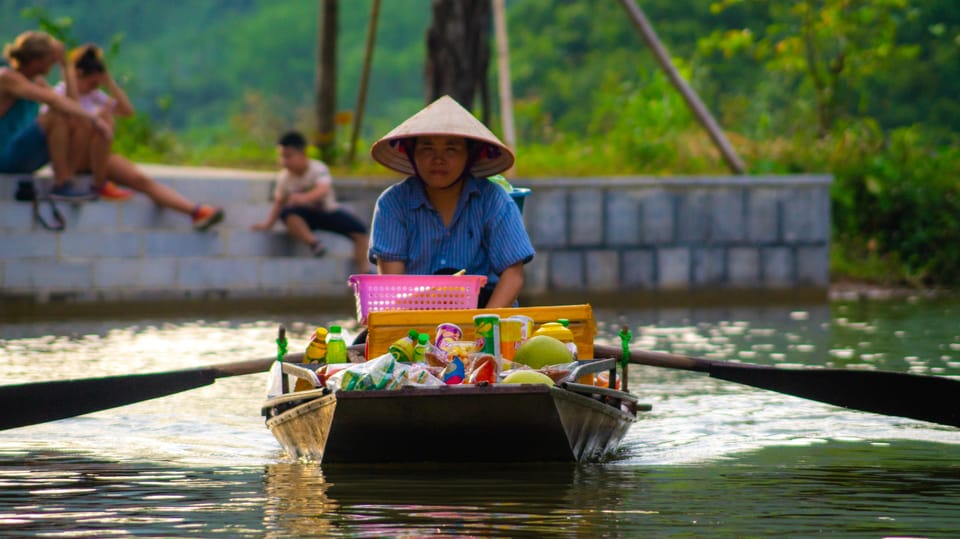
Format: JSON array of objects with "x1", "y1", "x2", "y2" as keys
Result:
[{"x1": 370, "y1": 176, "x2": 534, "y2": 283}]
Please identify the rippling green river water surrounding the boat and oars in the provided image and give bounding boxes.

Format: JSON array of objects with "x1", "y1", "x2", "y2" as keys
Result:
[{"x1": 0, "y1": 299, "x2": 960, "y2": 538}]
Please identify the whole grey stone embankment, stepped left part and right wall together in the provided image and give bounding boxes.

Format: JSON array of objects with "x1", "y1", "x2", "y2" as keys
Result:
[{"x1": 0, "y1": 166, "x2": 831, "y2": 307}]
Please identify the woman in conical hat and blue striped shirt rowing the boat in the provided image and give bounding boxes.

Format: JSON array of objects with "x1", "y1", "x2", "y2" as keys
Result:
[{"x1": 370, "y1": 96, "x2": 534, "y2": 308}]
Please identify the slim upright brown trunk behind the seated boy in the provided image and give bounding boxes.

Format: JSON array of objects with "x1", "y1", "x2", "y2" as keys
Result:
[{"x1": 314, "y1": 0, "x2": 339, "y2": 162}]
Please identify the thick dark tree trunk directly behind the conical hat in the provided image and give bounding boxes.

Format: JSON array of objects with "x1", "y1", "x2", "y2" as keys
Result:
[{"x1": 424, "y1": 0, "x2": 492, "y2": 123}]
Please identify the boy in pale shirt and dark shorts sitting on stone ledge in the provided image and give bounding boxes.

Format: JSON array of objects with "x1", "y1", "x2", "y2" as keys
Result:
[{"x1": 253, "y1": 131, "x2": 370, "y2": 272}]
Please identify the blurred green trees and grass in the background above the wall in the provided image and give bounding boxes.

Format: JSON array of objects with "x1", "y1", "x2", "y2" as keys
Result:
[{"x1": 0, "y1": 0, "x2": 960, "y2": 286}]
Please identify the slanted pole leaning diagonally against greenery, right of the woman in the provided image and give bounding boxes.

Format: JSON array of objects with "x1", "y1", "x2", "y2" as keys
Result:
[{"x1": 620, "y1": 0, "x2": 747, "y2": 174}]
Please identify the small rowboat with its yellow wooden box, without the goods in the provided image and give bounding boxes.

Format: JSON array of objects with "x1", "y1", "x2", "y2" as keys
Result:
[{"x1": 262, "y1": 296, "x2": 650, "y2": 464}]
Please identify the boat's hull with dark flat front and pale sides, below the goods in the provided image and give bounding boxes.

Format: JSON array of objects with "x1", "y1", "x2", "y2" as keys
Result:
[{"x1": 264, "y1": 384, "x2": 636, "y2": 464}]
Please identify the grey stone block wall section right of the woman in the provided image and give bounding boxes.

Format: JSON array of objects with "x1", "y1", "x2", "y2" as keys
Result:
[{"x1": 525, "y1": 176, "x2": 831, "y2": 291}]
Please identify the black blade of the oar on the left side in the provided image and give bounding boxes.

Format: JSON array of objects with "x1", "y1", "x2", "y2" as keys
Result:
[{"x1": 0, "y1": 368, "x2": 216, "y2": 430}]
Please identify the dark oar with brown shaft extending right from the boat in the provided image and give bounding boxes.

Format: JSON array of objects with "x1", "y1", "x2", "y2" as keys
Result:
[{"x1": 593, "y1": 344, "x2": 960, "y2": 427}]
